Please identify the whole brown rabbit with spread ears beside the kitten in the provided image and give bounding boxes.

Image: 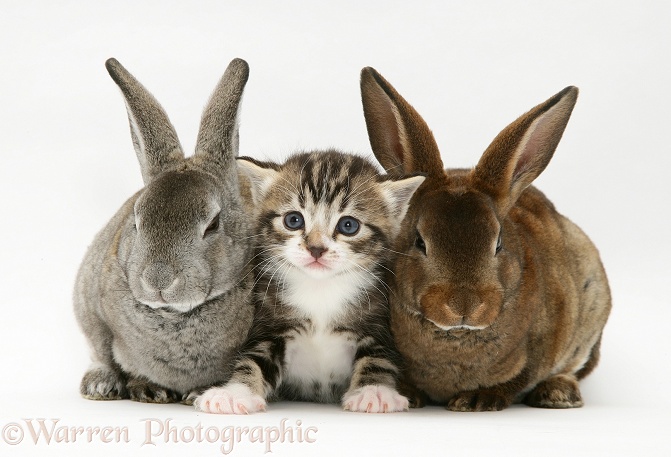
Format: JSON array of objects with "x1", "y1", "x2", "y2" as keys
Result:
[{"x1": 361, "y1": 68, "x2": 611, "y2": 411}]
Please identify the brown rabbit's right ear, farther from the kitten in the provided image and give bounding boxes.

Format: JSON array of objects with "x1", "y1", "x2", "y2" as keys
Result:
[{"x1": 473, "y1": 86, "x2": 578, "y2": 213}]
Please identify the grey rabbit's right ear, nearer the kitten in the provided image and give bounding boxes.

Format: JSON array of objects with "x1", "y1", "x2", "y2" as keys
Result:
[{"x1": 195, "y1": 59, "x2": 249, "y2": 174}]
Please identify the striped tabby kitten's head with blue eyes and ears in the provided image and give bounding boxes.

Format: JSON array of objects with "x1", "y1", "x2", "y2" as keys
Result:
[{"x1": 238, "y1": 151, "x2": 424, "y2": 282}]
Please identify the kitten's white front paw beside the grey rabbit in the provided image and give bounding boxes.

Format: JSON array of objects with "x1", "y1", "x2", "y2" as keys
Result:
[{"x1": 193, "y1": 383, "x2": 266, "y2": 414}]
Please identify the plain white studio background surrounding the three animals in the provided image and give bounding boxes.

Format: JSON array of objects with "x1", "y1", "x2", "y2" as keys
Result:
[{"x1": 0, "y1": 0, "x2": 671, "y2": 456}]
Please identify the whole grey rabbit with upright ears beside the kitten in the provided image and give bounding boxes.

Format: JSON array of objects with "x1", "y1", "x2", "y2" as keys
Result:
[{"x1": 74, "y1": 59, "x2": 254, "y2": 403}]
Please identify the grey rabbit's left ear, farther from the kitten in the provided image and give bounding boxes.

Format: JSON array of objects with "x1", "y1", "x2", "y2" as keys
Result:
[{"x1": 105, "y1": 59, "x2": 184, "y2": 184}]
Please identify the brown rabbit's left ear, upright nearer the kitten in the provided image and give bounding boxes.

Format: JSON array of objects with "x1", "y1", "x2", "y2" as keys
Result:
[{"x1": 361, "y1": 67, "x2": 443, "y2": 176}]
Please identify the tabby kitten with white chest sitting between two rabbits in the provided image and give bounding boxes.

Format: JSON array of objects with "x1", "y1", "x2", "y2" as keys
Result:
[{"x1": 195, "y1": 150, "x2": 424, "y2": 414}]
